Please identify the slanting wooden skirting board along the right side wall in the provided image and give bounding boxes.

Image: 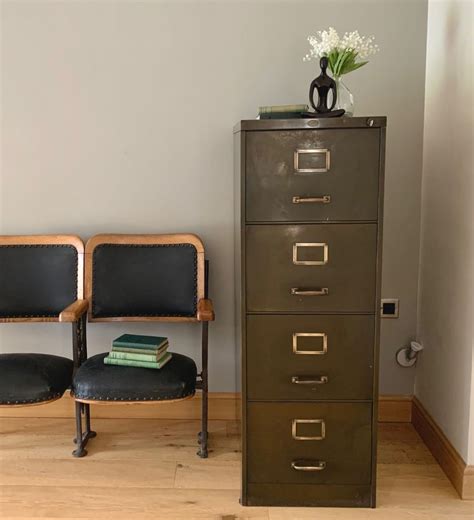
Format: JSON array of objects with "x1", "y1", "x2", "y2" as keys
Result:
[{"x1": 412, "y1": 397, "x2": 474, "y2": 500}]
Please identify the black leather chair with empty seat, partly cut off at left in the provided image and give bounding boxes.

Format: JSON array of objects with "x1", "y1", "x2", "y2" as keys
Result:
[{"x1": 0, "y1": 235, "x2": 87, "y2": 414}]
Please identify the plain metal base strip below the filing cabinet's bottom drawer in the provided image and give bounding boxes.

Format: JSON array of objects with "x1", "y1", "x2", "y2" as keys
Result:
[{"x1": 241, "y1": 484, "x2": 375, "y2": 507}]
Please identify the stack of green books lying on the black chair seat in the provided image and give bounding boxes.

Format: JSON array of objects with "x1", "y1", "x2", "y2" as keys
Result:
[{"x1": 104, "y1": 334, "x2": 171, "y2": 369}]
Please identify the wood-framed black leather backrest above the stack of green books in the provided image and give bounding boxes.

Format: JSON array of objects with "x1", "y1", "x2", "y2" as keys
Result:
[{"x1": 86, "y1": 235, "x2": 204, "y2": 321}]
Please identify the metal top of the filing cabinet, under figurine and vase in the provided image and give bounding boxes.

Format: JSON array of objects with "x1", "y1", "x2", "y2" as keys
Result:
[{"x1": 234, "y1": 116, "x2": 387, "y2": 133}]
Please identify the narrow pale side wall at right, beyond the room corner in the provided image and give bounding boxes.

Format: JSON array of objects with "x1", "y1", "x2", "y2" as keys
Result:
[{"x1": 415, "y1": 0, "x2": 474, "y2": 464}]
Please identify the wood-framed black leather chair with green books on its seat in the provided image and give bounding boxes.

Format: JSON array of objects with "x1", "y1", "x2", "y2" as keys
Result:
[{"x1": 72, "y1": 234, "x2": 214, "y2": 458}]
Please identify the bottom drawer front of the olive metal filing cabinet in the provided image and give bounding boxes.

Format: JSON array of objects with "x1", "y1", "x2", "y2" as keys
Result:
[{"x1": 247, "y1": 402, "x2": 372, "y2": 484}]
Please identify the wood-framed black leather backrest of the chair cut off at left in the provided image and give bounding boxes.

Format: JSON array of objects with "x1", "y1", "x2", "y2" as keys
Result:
[{"x1": 0, "y1": 235, "x2": 83, "y2": 321}]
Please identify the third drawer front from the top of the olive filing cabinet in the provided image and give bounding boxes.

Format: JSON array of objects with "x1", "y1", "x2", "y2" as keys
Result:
[{"x1": 246, "y1": 315, "x2": 375, "y2": 400}]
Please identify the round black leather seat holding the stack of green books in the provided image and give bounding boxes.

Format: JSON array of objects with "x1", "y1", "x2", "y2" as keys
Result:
[{"x1": 72, "y1": 353, "x2": 197, "y2": 401}]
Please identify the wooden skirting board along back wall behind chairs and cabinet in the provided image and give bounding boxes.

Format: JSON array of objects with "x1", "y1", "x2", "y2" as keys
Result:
[{"x1": 0, "y1": 392, "x2": 412, "y2": 422}]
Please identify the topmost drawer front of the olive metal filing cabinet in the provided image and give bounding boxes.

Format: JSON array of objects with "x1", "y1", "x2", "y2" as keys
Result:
[{"x1": 246, "y1": 129, "x2": 380, "y2": 222}]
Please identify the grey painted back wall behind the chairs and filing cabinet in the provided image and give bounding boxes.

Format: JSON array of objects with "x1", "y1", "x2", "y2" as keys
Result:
[{"x1": 0, "y1": 0, "x2": 427, "y2": 394}]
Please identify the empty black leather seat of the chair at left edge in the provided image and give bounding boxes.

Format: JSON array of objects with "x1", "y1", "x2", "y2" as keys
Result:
[{"x1": 0, "y1": 354, "x2": 73, "y2": 405}]
